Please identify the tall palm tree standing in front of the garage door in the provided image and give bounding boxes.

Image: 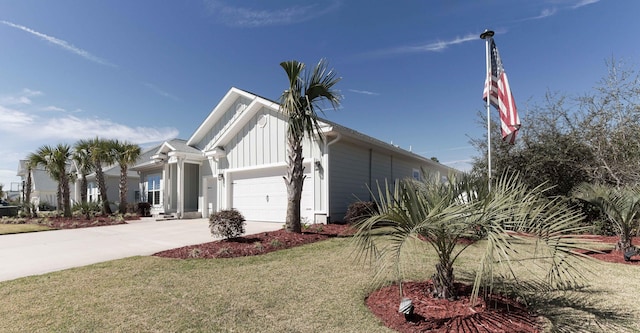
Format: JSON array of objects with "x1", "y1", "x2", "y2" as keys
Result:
[{"x1": 280, "y1": 59, "x2": 342, "y2": 233}]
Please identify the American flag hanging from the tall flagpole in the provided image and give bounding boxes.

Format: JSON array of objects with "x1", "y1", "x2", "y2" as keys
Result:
[{"x1": 482, "y1": 38, "x2": 520, "y2": 144}]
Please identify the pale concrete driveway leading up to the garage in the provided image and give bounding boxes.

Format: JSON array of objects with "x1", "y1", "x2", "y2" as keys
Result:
[{"x1": 0, "y1": 218, "x2": 282, "y2": 281}]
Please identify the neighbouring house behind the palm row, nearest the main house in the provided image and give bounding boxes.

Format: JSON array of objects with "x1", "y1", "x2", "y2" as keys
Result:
[{"x1": 71, "y1": 163, "x2": 140, "y2": 206}]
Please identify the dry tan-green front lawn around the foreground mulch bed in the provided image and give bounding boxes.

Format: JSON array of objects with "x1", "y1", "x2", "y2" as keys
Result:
[{"x1": 0, "y1": 238, "x2": 640, "y2": 332}]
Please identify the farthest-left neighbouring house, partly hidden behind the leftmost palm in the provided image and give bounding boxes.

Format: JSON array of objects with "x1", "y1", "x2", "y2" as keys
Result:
[{"x1": 17, "y1": 160, "x2": 58, "y2": 207}]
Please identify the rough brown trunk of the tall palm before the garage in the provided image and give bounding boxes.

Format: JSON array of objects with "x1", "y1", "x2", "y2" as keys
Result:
[{"x1": 285, "y1": 134, "x2": 304, "y2": 233}]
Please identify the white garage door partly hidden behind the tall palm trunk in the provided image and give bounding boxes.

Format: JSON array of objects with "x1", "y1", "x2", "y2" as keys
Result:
[{"x1": 231, "y1": 168, "x2": 313, "y2": 223}]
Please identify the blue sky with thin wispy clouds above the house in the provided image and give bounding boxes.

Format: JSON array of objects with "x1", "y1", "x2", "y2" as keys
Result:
[{"x1": 0, "y1": 0, "x2": 640, "y2": 190}]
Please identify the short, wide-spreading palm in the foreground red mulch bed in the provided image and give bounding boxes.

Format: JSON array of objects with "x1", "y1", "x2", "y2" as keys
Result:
[{"x1": 355, "y1": 174, "x2": 584, "y2": 300}]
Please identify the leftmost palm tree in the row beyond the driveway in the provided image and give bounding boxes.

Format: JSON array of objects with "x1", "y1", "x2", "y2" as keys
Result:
[{"x1": 29, "y1": 144, "x2": 71, "y2": 217}]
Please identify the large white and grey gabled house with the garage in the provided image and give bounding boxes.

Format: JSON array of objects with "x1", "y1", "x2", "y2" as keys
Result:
[{"x1": 131, "y1": 88, "x2": 457, "y2": 223}]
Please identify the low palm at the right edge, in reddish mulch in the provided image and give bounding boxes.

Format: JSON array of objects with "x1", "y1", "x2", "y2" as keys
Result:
[{"x1": 574, "y1": 183, "x2": 640, "y2": 255}]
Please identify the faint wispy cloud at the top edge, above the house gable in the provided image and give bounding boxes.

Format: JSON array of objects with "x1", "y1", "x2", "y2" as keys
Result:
[{"x1": 208, "y1": 0, "x2": 340, "y2": 28}]
